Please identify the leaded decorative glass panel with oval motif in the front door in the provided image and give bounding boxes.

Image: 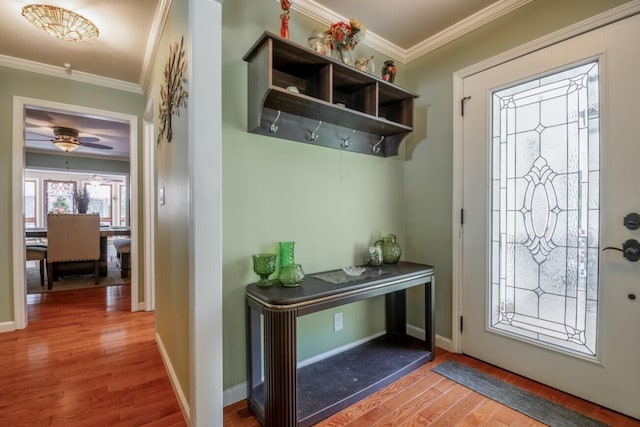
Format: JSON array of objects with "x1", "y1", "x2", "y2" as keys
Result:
[{"x1": 490, "y1": 62, "x2": 600, "y2": 356}]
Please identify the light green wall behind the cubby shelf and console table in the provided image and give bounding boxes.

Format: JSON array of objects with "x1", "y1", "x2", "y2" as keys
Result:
[{"x1": 222, "y1": 0, "x2": 405, "y2": 389}]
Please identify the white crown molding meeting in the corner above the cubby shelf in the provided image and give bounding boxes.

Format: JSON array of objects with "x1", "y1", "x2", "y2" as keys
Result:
[{"x1": 290, "y1": 0, "x2": 532, "y2": 64}]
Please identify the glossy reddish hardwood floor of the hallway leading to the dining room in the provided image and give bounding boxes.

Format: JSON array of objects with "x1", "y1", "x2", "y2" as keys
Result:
[{"x1": 0, "y1": 286, "x2": 186, "y2": 427}]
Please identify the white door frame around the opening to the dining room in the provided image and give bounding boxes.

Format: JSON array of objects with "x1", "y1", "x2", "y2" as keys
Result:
[{"x1": 11, "y1": 96, "x2": 140, "y2": 329}]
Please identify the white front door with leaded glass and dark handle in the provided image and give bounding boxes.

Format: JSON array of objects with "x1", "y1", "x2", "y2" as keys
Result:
[{"x1": 462, "y1": 16, "x2": 640, "y2": 418}]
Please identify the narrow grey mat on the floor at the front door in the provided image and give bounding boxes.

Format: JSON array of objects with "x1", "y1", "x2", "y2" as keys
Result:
[{"x1": 431, "y1": 360, "x2": 606, "y2": 427}]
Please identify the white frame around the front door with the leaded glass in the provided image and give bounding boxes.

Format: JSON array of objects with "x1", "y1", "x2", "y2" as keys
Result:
[{"x1": 451, "y1": 0, "x2": 640, "y2": 353}]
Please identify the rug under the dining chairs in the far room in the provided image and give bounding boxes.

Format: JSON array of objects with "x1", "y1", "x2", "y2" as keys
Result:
[{"x1": 26, "y1": 263, "x2": 131, "y2": 294}]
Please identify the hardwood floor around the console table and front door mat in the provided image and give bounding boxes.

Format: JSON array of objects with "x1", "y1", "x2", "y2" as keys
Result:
[{"x1": 224, "y1": 349, "x2": 640, "y2": 427}]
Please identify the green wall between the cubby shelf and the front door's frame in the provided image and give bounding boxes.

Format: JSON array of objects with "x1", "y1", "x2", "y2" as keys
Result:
[{"x1": 404, "y1": 0, "x2": 626, "y2": 337}]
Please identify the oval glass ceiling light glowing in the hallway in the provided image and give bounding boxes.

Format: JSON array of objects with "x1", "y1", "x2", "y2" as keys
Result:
[{"x1": 22, "y1": 4, "x2": 100, "y2": 42}]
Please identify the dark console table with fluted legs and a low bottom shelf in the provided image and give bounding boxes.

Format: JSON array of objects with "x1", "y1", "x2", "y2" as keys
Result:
[{"x1": 245, "y1": 261, "x2": 435, "y2": 427}]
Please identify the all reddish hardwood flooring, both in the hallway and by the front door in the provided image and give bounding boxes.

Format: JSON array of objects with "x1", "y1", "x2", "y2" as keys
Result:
[{"x1": 0, "y1": 286, "x2": 640, "y2": 427}]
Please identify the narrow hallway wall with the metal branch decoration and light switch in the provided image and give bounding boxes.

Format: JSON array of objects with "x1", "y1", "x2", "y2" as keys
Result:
[{"x1": 145, "y1": 1, "x2": 191, "y2": 402}]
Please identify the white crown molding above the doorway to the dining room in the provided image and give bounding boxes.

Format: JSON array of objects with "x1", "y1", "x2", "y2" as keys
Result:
[{"x1": 0, "y1": 55, "x2": 142, "y2": 94}]
